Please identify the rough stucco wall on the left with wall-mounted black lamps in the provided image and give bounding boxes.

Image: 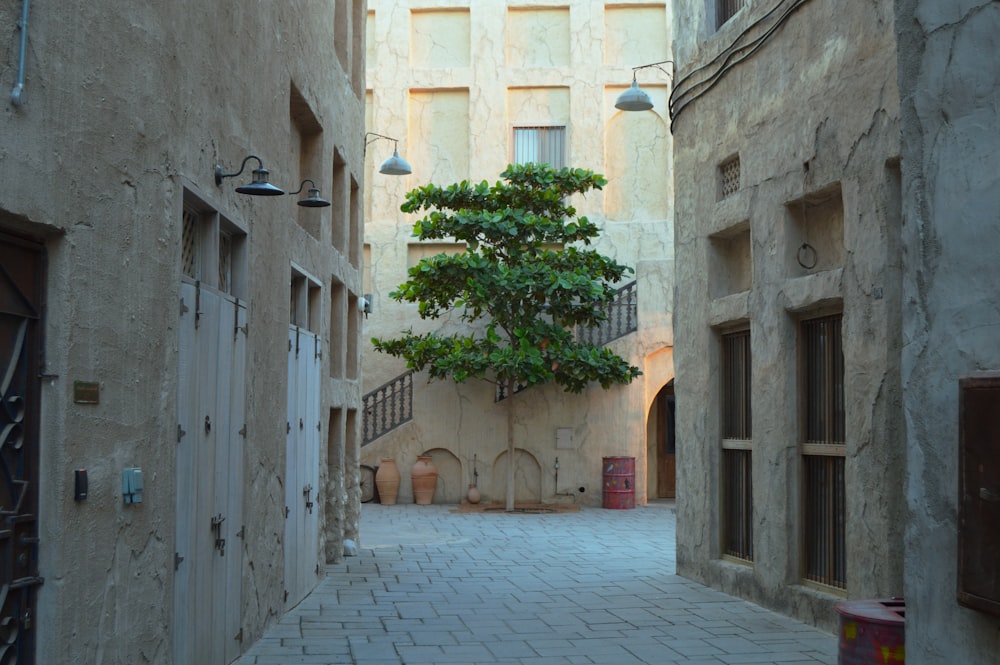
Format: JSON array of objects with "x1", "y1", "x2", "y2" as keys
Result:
[{"x1": 0, "y1": 0, "x2": 364, "y2": 665}]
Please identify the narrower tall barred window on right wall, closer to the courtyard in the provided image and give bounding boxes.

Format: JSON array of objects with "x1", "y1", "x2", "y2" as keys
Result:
[{"x1": 721, "y1": 330, "x2": 753, "y2": 561}]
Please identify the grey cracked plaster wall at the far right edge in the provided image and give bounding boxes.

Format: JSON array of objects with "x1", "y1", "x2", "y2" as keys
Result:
[{"x1": 895, "y1": 0, "x2": 1000, "y2": 665}]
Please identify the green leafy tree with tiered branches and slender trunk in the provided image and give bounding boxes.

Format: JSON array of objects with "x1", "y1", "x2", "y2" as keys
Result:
[{"x1": 372, "y1": 164, "x2": 640, "y2": 511}]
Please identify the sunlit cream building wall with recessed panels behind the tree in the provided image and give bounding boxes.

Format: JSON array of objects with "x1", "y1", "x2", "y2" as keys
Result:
[{"x1": 362, "y1": 0, "x2": 673, "y2": 504}]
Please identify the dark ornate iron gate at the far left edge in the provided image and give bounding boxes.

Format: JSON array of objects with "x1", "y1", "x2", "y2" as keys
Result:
[{"x1": 0, "y1": 234, "x2": 44, "y2": 665}]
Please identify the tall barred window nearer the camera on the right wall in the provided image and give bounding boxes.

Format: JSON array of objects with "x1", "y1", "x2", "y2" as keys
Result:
[{"x1": 802, "y1": 314, "x2": 847, "y2": 589}]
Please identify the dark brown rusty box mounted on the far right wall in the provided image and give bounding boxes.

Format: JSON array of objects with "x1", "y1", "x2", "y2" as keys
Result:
[{"x1": 958, "y1": 373, "x2": 1000, "y2": 615}]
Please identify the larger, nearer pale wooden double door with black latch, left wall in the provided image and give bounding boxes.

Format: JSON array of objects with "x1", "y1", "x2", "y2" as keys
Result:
[{"x1": 174, "y1": 283, "x2": 247, "y2": 665}]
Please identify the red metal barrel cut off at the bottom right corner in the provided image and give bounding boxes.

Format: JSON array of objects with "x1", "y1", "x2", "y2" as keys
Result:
[{"x1": 837, "y1": 598, "x2": 906, "y2": 665}]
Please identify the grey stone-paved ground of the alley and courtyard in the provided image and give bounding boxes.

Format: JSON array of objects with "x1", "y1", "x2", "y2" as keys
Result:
[{"x1": 236, "y1": 503, "x2": 837, "y2": 665}]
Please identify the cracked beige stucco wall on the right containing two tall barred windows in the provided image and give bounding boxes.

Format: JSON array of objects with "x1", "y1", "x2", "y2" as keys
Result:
[{"x1": 673, "y1": 0, "x2": 906, "y2": 629}]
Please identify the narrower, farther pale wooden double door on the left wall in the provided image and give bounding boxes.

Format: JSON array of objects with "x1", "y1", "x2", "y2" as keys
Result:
[{"x1": 285, "y1": 325, "x2": 321, "y2": 608}]
